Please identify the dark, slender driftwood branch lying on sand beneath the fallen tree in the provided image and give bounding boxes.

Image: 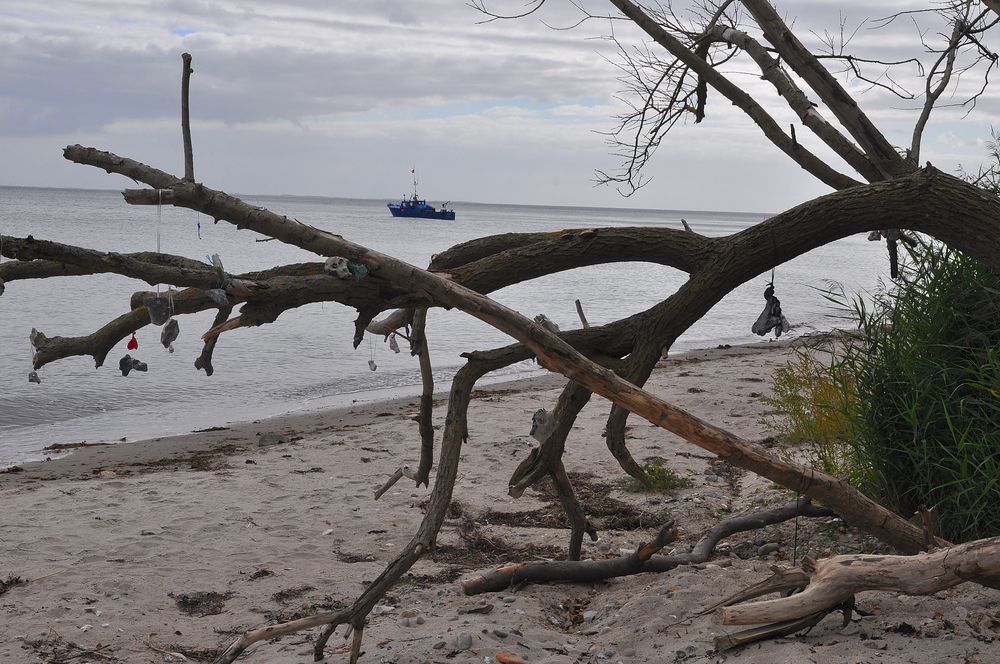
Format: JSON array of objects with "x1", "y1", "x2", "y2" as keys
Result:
[{"x1": 462, "y1": 498, "x2": 834, "y2": 595}]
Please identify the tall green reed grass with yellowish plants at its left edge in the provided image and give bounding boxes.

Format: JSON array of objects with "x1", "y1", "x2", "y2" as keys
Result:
[{"x1": 772, "y1": 243, "x2": 1000, "y2": 541}]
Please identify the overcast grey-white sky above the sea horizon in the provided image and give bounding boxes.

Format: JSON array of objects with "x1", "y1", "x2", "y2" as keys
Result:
[{"x1": 0, "y1": 0, "x2": 1000, "y2": 212}]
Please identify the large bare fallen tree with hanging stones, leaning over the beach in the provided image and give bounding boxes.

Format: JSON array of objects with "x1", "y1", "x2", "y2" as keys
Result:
[{"x1": 0, "y1": 0, "x2": 1000, "y2": 662}]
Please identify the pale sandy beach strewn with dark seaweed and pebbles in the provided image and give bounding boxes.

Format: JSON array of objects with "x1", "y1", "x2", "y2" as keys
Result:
[{"x1": 0, "y1": 343, "x2": 1000, "y2": 664}]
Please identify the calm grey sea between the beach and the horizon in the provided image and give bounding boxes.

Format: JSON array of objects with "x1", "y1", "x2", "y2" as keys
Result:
[{"x1": 0, "y1": 187, "x2": 888, "y2": 468}]
